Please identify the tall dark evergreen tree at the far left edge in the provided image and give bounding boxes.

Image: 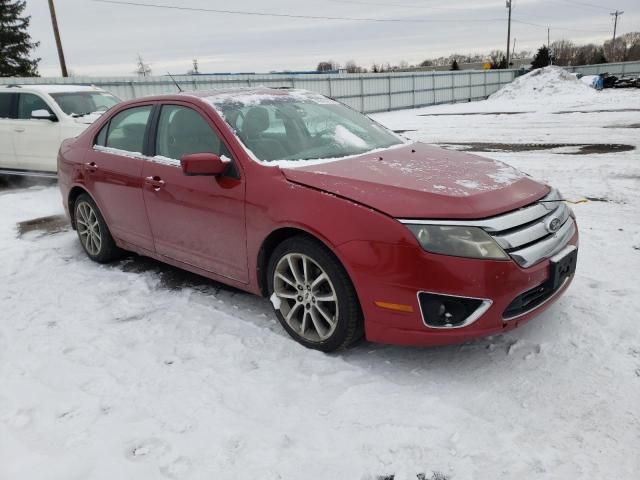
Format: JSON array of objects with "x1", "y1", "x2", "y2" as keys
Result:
[{"x1": 0, "y1": 0, "x2": 40, "y2": 77}]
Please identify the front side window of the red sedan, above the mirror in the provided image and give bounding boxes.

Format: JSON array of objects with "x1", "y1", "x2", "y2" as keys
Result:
[{"x1": 156, "y1": 105, "x2": 230, "y2": 160}]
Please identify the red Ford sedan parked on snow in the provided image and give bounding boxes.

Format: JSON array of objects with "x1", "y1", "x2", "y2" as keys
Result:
[{"x1": 58, "y1": 88, "x2": 578, "y2": 351}]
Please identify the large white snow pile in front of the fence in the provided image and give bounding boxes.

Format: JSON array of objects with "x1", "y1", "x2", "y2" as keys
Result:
[{"x1": 489, "y1": 66, "x2": 595, "y2": 101}]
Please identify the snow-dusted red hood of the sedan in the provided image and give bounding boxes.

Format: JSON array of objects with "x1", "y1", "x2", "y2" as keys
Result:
[{"x1": 281, "y1": 143, "x2": 549, "y2": 219}]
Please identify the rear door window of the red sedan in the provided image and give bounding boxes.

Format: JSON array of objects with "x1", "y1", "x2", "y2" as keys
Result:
[{"x1": 107, "y1": 105, "x2": 151, "y2": 153}]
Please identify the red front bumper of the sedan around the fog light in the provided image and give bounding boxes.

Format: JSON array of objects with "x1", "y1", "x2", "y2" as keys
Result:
[{"x1": 338, "y1": 231, "x2": 578, "y2": 346}]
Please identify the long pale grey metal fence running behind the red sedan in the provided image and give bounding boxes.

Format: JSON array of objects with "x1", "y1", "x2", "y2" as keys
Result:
[{"x1": 0, "y1": 70, "x2": 518, "y2": 113}]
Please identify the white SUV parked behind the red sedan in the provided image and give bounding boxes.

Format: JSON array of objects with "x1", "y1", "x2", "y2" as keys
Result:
[{"x1": 0, "y1": 85, "x2": 120, "y2": 177}]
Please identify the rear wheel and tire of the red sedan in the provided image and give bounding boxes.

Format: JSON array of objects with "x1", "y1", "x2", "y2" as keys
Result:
[{"x1": 73, "y1": 193, "x2": 123, "y2": 263}]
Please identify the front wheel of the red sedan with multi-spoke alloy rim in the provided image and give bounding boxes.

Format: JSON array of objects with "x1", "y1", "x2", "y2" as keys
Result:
[{"x1": 267, "y1": 235, "x2": 364, "y2": 352}]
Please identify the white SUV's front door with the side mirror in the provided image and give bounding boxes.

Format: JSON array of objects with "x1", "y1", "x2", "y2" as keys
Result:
[{"x1": 13, "y1": 93, "x2": 61, "y2": 172}]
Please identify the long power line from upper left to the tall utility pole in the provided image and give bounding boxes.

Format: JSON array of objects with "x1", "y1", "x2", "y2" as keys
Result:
[{"x1": 93, "y1": 0, "x2": 502, "y2": 23}]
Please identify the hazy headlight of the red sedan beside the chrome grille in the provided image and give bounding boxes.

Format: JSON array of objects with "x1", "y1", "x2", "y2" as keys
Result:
[{"x1": 407, "y1": 224, "x2": 509, "y2": 260}]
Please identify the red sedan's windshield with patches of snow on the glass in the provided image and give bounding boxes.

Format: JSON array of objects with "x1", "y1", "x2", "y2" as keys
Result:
[{"x1": 211, "y1": 92, "x2": 403, "y2": 162}]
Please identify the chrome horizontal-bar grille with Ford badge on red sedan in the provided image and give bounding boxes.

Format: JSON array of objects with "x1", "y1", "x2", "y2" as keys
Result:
[{"x1": 401, "y1": 189, "x2": 576, "y2": 268}]
